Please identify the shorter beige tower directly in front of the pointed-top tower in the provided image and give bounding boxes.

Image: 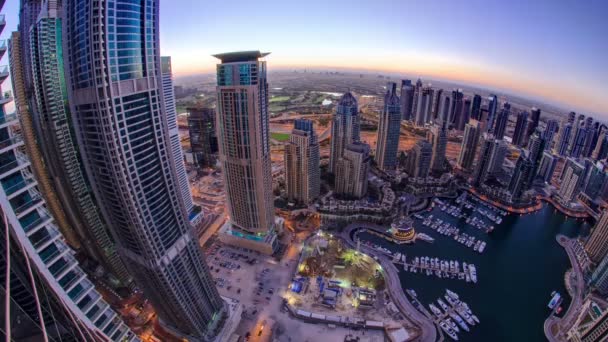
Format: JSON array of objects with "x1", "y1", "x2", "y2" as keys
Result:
[{"x1": 335, "y1": 142, "x2": 370, "y2": 198}]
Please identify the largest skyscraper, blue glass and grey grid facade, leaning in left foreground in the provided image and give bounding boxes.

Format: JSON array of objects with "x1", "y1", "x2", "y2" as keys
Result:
[{"x1": 63, "y1": 0, "x2": 226, "y2": 340}]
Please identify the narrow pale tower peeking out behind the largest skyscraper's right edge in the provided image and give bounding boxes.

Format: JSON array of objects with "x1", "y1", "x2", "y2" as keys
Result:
[{"x1": 160, "y1": 56, "x2": 197, "y2": 226}]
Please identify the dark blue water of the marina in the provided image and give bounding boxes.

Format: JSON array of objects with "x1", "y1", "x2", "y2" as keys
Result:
[{"x1": 359, "y1": 199, "x2": 590, "y2": 341}]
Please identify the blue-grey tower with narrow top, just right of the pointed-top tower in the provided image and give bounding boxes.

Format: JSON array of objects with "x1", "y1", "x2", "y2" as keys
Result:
[{"x1": 376, "y1": 83, "x2": 401, "y2": 171}]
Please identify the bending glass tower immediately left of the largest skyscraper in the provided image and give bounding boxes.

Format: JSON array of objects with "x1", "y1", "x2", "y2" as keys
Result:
[{"x1": 11, "y1": 3, "x2": 131, "y2": 286}]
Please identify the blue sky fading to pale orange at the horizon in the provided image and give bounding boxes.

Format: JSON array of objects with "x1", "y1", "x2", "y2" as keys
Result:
[{"x1": 0, "y1": 0, "x2": 608, "y2": 116}]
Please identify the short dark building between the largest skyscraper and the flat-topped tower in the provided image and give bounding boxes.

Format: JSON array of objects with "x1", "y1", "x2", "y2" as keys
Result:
[{"x1": 187, "y1": 107, "x2": 219, "y2": 168}]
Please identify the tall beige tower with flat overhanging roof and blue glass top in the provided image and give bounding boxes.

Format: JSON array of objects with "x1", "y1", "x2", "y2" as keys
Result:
[{"x1": 215, "y1": 51, "x2": 280, "y2": 254}]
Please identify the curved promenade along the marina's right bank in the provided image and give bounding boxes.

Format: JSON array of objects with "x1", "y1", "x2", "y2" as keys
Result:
[{"x1": 544, "y1": 235, "x2": 585, "y2": 342}]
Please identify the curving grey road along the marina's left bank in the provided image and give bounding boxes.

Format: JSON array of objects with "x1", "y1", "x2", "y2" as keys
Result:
[{"x1": 340, "y1": 222, "x2": 444, "y2": 342}]
